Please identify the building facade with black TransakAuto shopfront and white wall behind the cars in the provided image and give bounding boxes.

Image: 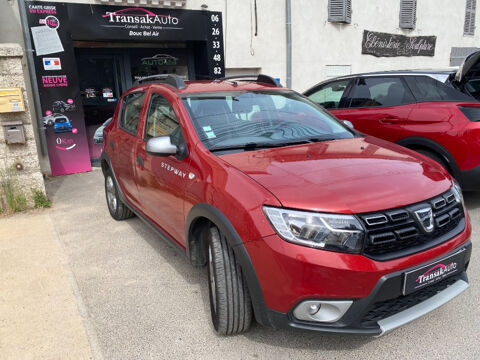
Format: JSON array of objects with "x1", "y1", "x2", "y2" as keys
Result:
[{"x1": 0, "y1": 0, "x2": 480, "y2": 181}]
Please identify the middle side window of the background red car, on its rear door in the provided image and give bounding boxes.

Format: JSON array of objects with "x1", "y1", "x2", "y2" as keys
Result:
[{"x1": 350, "y1": 77, "x2": 415, "y2": 108}]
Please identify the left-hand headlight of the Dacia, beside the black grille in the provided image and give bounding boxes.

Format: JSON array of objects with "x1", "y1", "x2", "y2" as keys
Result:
[{"x1": 263, "y1": 206, "x2": 364, "y2": 253}]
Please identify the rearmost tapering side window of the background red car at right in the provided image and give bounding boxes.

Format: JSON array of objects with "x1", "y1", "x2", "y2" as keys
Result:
[{"x1": 405, "y1": 75, "x2": 474, "y2": 102}]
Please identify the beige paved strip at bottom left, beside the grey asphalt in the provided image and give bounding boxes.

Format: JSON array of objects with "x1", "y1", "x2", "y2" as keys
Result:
[{"x1": 0, "y1": 211, "x2": 92, "y2": 360}]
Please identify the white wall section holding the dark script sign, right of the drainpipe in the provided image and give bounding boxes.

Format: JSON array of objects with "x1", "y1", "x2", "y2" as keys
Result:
[{"x1": 292, "y1": 0, "x2": 480, "y2": 90}]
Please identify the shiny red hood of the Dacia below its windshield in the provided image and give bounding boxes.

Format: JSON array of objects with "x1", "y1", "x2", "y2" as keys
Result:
[{"x1": 220, "y1": 137, "x2": 451, "y2": 213}]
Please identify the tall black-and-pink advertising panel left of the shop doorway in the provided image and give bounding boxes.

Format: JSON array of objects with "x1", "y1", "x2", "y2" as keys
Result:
[{"x1": 26, "y1": 1, "x2": 91, "y2": 175}]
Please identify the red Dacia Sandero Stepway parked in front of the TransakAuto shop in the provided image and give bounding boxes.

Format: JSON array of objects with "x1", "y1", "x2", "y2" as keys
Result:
[{"x1": 102, "y1": 75, "x2": 471, "y2": 335}]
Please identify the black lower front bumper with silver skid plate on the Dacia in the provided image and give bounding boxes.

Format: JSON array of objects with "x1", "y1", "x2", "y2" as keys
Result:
[{"x1": 262, "y1": 242, "x2": 472, "y2": 336}]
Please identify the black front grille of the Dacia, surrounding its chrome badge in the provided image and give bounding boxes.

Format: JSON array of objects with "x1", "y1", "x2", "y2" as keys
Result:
[{"x1": 359, "y1": 190, "x2": 465, "y2": 261}]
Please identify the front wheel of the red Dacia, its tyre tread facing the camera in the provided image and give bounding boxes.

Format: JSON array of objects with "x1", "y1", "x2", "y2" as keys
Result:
[{"x1": 208, "y1": 227, "x2": 252, "y2": 335}]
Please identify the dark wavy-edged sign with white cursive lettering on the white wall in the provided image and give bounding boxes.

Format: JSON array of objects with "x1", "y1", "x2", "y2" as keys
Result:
[{"x1": 362, "y1": 30, "x2": 437, "y2": 56}]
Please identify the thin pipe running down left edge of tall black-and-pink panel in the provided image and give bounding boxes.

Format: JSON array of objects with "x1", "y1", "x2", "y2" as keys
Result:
[{"x1": 18, "y1": 0, "x2": 48, "y2": 155}]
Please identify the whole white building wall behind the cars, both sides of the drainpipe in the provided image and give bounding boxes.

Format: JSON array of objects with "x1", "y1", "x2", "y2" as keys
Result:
[{"x1": 8, "y1": 0, "x2": 480, "y2": 91}]
